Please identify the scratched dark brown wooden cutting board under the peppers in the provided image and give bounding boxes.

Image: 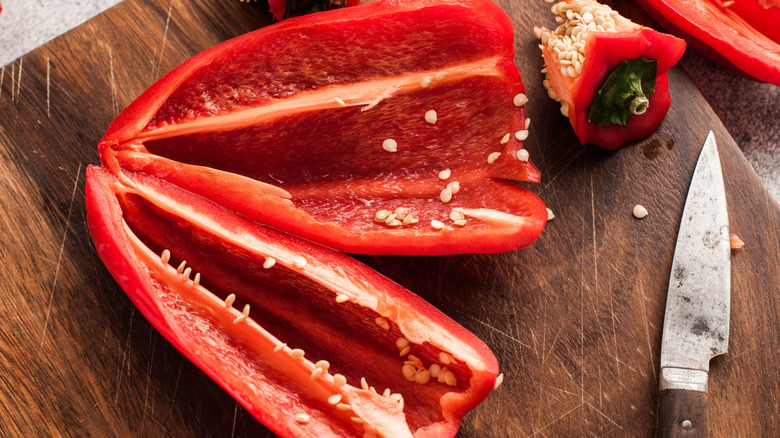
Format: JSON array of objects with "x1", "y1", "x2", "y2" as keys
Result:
[{"x1": 0, "y1": 0, "x2": 780, "y2": 437}]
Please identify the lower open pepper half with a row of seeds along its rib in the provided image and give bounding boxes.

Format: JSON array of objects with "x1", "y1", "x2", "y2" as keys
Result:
[{"x1": 86, "y1": 166, "x2": 497, "y2": 437}]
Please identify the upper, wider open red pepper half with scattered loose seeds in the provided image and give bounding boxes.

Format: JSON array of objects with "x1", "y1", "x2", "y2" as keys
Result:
[{"x1": 99, "y1": 0, "x2": 546, "y2": 254}]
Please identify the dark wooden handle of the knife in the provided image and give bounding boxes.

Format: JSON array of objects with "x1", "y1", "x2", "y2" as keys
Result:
[{"x1": 655, "y1": 389, "x2": 707, "y2": 438}]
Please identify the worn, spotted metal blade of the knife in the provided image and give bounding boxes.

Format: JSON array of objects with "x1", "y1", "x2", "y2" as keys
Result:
[{"x1": 661, "y1": 132, "x2": 731, "y2": 378}]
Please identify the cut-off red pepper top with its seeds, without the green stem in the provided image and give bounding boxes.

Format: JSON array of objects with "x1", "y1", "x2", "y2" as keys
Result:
[{"x1": 540, "y1": 0, "x2": 685, "y2": 149}]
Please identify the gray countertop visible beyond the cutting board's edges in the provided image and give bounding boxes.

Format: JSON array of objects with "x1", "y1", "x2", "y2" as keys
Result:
[{"x1": 0, "y1": 0, "x2": 780, "y2": 199}]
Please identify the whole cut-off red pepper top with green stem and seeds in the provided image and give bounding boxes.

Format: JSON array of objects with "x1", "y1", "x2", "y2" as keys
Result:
[{"x1": 535, "y1": 0, "x2": 685, "y2": 149}]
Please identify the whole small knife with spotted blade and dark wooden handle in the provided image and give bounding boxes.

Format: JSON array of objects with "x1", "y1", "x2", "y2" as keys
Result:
[{"x1": 656, "y1": 131, "x2": 731, "y2": 437}]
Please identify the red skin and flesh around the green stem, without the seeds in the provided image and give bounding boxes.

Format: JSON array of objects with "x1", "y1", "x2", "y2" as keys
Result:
[{"x1": 542, "y1": 0, "x2": 685, "y2": 150}]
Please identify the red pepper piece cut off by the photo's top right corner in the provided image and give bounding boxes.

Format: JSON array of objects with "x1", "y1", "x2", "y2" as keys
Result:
[{"x1": 639, "y1": 0, "x2": 780, "y2": 85}]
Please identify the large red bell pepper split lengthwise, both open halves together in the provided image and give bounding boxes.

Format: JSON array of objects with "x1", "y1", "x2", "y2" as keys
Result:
[{"x1": 86, "y1": 0, "x2": 547, "y2": 437}]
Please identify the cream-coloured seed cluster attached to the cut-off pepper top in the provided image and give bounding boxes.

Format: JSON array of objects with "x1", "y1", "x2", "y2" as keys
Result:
[{"x1": 534, "y1": 0, "x2": 619, "y2": 109}]
